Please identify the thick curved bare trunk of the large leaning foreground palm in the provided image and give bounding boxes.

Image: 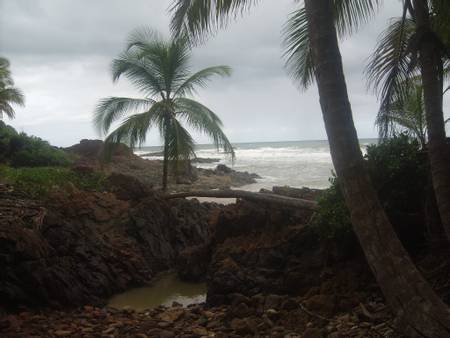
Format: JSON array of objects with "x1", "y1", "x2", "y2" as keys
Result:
[{"x1": 305, "y1": 0, "x2": 450, "y2": 338}]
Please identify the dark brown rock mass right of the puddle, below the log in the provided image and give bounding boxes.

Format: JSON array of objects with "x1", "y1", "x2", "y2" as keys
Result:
[{"x1": 202, "y1": 202, "x2": 372, "y2": 305}]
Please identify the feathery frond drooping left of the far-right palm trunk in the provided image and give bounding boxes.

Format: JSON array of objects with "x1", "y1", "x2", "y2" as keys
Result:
[{"x1": 365, "y1": 12, "x2": 415, "y2": 138}]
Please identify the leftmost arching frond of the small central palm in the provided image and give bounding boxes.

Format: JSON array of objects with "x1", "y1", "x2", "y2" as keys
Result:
[{"x1": 94, "y1": 97, "x2": 156, "y2": 134}]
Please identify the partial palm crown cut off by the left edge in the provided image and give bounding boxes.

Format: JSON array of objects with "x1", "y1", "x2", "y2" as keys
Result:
[{"x1": 0, "y1": 57, "x2": 25, "y2": 119}]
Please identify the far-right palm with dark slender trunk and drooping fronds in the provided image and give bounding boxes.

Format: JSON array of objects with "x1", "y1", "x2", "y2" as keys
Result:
[{"x1": 367, "y1": 0, "x2": 450, "y2": 240}]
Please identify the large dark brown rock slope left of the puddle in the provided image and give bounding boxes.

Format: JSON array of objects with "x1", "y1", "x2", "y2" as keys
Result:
[{"x1": 0, "y1": 185, "x2": 215, "y2": 307}]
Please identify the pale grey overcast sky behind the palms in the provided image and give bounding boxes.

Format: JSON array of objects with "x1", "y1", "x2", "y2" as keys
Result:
[{"x1": 0, "y1": 0, "x2": 449, "y2": 146}]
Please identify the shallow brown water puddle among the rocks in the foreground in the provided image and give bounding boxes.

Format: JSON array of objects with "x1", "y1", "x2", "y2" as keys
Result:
[{"x1": 108, "y1": 273, "x2": 206, "y2": 311}]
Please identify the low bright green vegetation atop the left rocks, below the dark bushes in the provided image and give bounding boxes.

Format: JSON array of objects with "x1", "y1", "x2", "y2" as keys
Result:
[{"x1": 0, "y1": 165, "x2": 105, "y2": 197}]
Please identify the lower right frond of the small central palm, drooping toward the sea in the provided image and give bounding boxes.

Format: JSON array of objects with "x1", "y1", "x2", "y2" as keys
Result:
[{"x1": 175, "y1": 98, "x2": 235, "y2": 161}]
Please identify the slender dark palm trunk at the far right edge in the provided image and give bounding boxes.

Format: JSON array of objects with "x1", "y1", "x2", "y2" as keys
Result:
[{"x1": 414, "y1": 0, "x2": 450, "y2": 241}]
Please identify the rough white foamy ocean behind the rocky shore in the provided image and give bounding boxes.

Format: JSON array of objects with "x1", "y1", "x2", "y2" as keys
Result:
[{"x1": 135, "y1": 139, "x2": 377, "y2": 191}]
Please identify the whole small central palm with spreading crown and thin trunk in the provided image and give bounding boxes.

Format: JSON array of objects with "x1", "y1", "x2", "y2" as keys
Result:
[{"x1": 94, "y1": 29, "x2": 234, "y2": 191}]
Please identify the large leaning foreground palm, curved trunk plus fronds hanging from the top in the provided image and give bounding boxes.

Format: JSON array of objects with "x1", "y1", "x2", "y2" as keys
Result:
[{"x1": 172, "y1": 0, "x2": 450, "y2": 337}]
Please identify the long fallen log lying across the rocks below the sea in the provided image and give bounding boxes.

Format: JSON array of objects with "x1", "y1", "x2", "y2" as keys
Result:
[{"x1": 165, "y1": 190, "x2": 317, "y2": 210}]
